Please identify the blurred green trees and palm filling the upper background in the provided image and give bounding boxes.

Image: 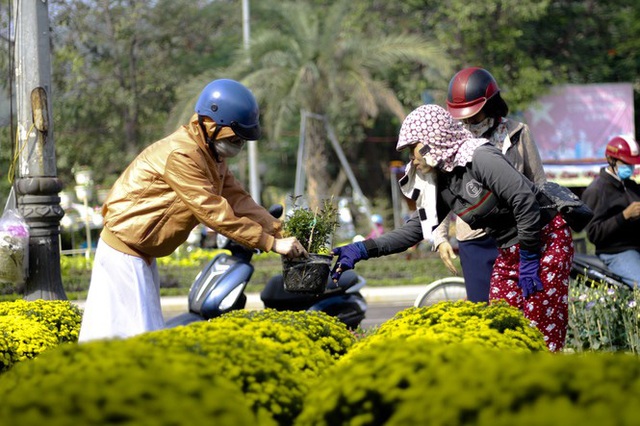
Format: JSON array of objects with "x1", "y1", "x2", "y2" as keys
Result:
[{"x1": 0, "y1": 0, "x2": 640, "y2": 213}]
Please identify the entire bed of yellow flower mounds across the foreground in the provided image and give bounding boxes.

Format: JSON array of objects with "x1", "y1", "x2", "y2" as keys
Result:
[{"x1": 0, "y1": 301, "x2": 640, "y2": 426}]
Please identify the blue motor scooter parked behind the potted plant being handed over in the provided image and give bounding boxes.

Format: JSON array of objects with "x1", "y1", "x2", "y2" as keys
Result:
[{"x1": 166, "y1": 205, "x2": 367, "y2": 329}]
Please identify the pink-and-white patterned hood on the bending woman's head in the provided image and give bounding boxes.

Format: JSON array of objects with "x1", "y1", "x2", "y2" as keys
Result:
[{"x1": 396, "y1": 105, "x2": 489, "y2": 172}]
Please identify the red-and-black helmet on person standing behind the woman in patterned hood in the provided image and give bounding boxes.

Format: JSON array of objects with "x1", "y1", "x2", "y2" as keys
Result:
[{"x1": 447, "y1": 67, "x2": 508, "y2": 120}]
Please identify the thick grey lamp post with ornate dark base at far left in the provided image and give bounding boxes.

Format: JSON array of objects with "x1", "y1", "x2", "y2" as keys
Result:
[{"x1": 13, "y1": 0, "x2": 67, "y2": 300}]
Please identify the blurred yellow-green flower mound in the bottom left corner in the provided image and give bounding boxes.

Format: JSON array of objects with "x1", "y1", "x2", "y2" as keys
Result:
[{"x1": 0, "y1": 340, "x2": 262, "y2": 426}]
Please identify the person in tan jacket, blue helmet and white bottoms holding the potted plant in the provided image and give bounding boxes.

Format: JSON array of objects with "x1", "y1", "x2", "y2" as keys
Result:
[{"x1": 79, "y1": 79, "x2": 307, "y2": 342}]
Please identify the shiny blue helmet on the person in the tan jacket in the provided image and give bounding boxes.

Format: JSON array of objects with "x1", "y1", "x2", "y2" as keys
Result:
[{"x1": 195, "y1": 79, "x2": 260, "y2": 140}]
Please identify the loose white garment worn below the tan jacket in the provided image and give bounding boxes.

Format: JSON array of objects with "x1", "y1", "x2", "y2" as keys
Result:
[{"x1": 78, "y1": 240, "x2": 164, "y2": 342}]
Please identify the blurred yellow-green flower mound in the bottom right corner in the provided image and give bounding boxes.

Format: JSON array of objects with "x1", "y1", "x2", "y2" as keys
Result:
[{"x1": 296, "y1": 337, "x2": 640, "y2": 426}]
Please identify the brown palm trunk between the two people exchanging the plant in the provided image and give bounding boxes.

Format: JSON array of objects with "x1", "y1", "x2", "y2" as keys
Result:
[{"x1": 305, "y1": 119, "x2": 330, "y2": 209}]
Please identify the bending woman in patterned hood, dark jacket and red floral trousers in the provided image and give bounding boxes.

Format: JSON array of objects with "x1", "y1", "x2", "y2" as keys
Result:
[{"x1": 333, "y1": 105, "x2": 573, "y2": 351}]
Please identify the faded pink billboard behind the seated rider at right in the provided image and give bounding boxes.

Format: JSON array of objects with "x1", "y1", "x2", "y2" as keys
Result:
[{"x1": 524, "y1": 83, "x2": 635, "y2": 163}]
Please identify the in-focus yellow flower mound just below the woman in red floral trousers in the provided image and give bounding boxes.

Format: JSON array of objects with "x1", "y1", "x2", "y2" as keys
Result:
[{"x1": 347, "y1": 301, "x2": 547, "y2": 357}]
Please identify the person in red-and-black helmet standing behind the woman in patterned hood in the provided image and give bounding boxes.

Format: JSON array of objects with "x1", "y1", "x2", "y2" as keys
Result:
[{"x1": 433, "y1": 67, "x2": 546, "y2": 302}]
